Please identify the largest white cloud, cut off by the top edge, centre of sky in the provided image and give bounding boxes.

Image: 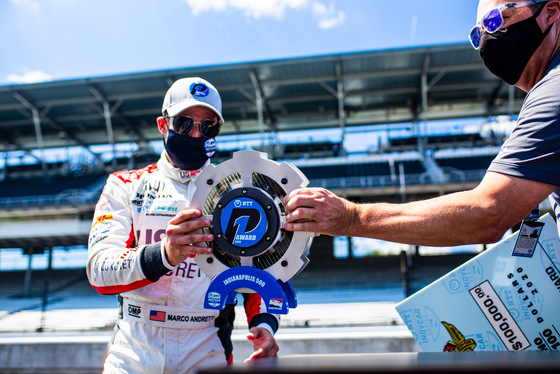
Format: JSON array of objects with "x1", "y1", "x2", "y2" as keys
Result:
[{"x1": 183, "y1": 0, "x2": 346, "y2": 29}]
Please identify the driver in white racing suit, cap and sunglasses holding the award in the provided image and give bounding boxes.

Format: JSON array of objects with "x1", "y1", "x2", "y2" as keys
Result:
[{"x1": 86, "y1": 78, "x2": 279, "y2": 373}]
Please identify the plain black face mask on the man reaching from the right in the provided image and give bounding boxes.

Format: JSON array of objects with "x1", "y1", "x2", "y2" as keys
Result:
[{"x1": 479, "y1": 5, "x2": 552, "y2": 85}]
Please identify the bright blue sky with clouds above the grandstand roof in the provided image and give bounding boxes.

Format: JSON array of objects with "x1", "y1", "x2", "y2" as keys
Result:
[{"x1": 0, "y1": 0, "x2": 478, "y2": 85}]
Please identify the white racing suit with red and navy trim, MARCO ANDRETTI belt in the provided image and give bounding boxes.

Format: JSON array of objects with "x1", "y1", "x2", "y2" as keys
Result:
[{"x1": 87, "y1": 153, "x2": 278, "y2": 373}]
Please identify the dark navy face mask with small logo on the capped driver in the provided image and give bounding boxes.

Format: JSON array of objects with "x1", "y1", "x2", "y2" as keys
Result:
[{"x1": 165, "y1": 129, "x2": 216, "y2": 170}]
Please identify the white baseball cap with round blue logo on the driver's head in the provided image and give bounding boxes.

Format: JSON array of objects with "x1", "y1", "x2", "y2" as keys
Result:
[{"x1": 161, "y1": 77, "x2": 224, "y2": 123}]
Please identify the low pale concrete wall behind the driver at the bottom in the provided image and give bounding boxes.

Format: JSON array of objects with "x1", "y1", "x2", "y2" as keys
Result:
[{"x1": 0, "y1": 327, "x2": 419, "y2": 374}]
